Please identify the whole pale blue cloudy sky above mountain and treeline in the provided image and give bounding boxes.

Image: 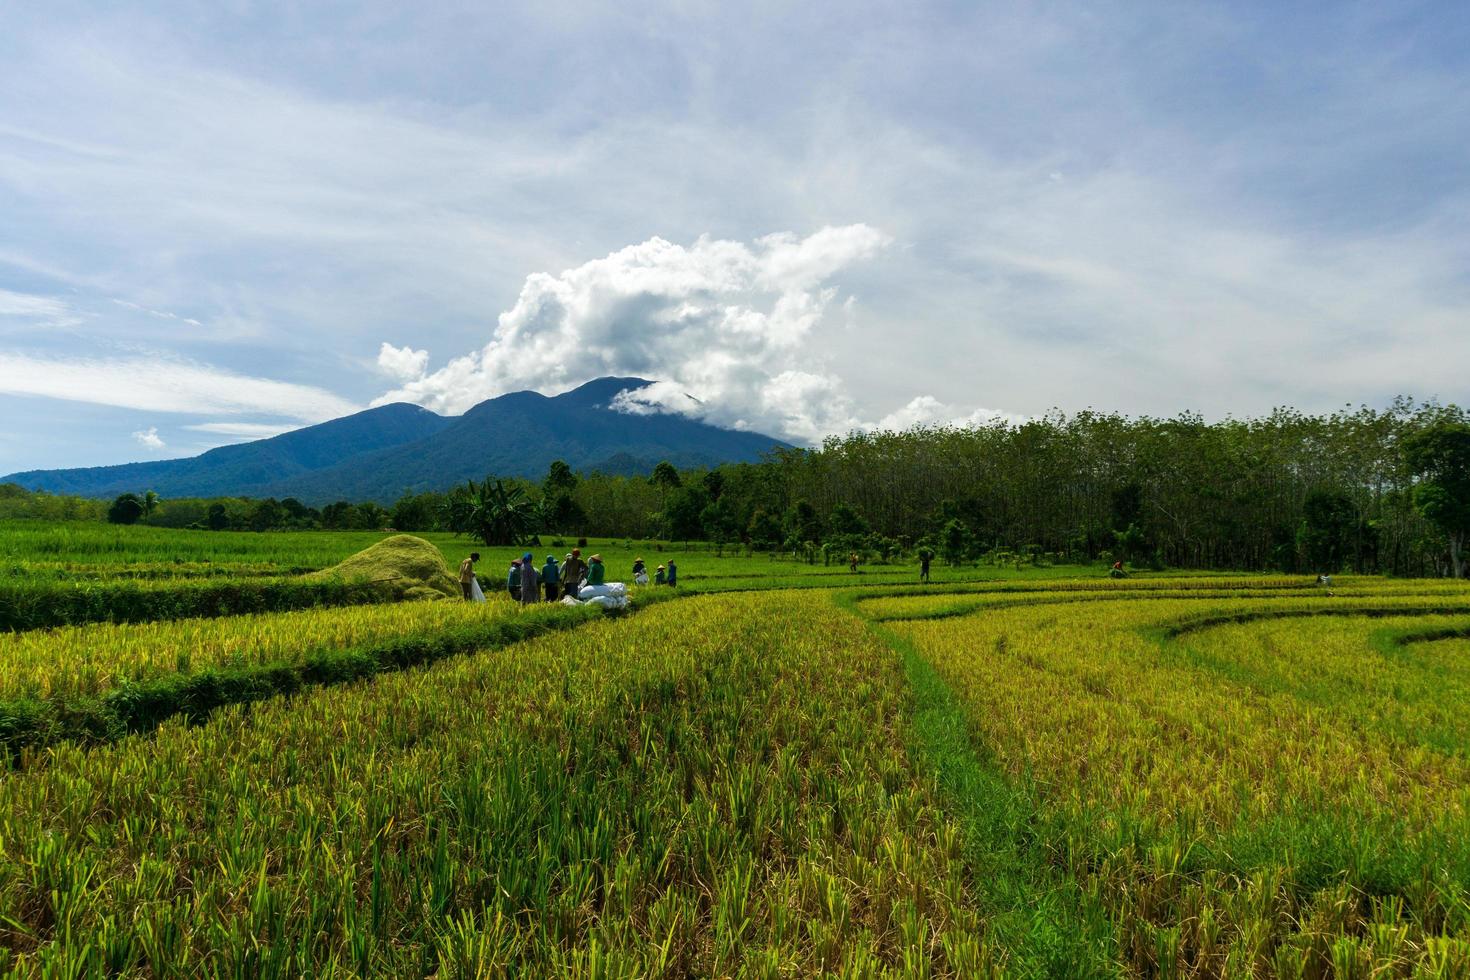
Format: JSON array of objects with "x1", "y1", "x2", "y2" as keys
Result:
[{"x1": 0, "y1": 0, "x2": 1470, "y2": 473}]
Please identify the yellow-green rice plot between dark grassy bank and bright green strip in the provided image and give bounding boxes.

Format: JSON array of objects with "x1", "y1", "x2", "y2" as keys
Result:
[{"x1": 0, "y1": 594, "x2": 1007, "y2": 977}]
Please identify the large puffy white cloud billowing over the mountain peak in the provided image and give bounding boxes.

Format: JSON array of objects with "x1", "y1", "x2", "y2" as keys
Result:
[{"x1": 375, "y1": 225, "x2": 889, "y2": 441}]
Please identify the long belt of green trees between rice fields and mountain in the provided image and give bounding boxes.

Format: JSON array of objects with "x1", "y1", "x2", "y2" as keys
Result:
[{"x1": 0, "y1": 398, "x2": 1470, "y2": 574}]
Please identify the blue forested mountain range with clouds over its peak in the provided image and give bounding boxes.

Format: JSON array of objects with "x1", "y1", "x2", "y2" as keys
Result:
[{"x1": 0, "y1": 378, "x2": 786, "y2": 504}]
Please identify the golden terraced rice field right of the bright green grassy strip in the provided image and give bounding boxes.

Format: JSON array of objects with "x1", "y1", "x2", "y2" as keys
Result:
[{"x1": 861, "y1": 582, "x2": 1470, "y2": 977}]
